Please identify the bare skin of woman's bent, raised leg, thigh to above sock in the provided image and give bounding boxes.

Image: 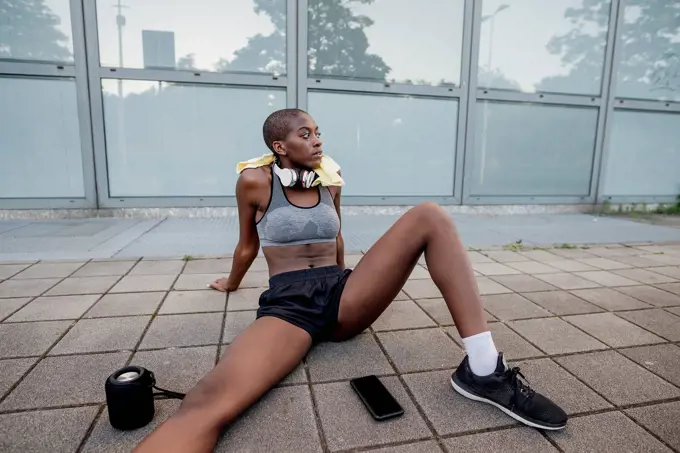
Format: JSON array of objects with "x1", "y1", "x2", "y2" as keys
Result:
[{"x1": 335, "y1": 203, "x2": 488, "y2": 339}]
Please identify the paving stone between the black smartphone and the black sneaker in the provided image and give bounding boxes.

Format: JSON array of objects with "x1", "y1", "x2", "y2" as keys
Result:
[{"x1": 404, "y1": 370, "x2": 517, "y2": 436}]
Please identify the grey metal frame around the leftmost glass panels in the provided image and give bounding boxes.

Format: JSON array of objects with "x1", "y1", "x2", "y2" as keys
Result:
[{"x1": 0, "y1": 0, "x2": 97, "y2": 209}]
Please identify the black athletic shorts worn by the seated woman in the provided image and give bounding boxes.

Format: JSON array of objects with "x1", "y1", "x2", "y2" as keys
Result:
[{"x1": 257, "y1": 266, "x2": 352, "y2": 343}]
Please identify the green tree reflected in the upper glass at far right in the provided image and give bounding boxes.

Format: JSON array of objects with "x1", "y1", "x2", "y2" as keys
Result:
[{"x1": 539, "y1": 0, "x2": 680, "y2": 97}]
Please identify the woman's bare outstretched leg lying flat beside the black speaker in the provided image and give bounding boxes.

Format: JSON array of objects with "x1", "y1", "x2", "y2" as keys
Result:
[{"x1": 134, "y1": 317, "x2": 312, "y2": 453}]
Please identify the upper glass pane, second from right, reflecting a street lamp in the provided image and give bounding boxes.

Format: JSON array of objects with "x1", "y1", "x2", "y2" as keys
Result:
[{"x1": 478, "y1": 0, "x2": 610, "y2": 94}]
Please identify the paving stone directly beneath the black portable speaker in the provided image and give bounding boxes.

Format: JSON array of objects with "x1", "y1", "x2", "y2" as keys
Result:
[{"x1": 82, "y1": 400, "x2": 180, "y2": 453}]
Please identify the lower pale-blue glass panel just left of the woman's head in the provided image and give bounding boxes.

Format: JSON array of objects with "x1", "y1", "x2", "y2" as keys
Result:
[{"x1": 102, "y1": 80, "x2": 286, "y2": 197}]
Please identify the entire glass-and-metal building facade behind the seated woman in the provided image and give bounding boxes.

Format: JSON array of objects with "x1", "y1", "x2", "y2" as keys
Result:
[{"x1": 0, "y1": 0, "x2": 680, "y2": 209}]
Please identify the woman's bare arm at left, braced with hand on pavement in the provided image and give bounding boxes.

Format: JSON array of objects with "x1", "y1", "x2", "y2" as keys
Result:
[{"x1": 210, "y1": 171, "x2": 262, "y2": 291}]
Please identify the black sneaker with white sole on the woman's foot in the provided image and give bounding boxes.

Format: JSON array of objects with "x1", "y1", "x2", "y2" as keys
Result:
[{"x1": 451, "y1": 353, "x2": 568, "y2": 429}]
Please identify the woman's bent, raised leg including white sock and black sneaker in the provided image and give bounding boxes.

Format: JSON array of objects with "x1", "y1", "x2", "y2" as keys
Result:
[{"x1": 334, "y1": 203, "x2": 567, "y2": 429}]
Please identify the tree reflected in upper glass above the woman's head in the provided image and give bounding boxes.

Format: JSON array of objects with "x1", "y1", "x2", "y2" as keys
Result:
[{"x1": 216, "y1": 0, "x2": 390, "y2": 80}]
